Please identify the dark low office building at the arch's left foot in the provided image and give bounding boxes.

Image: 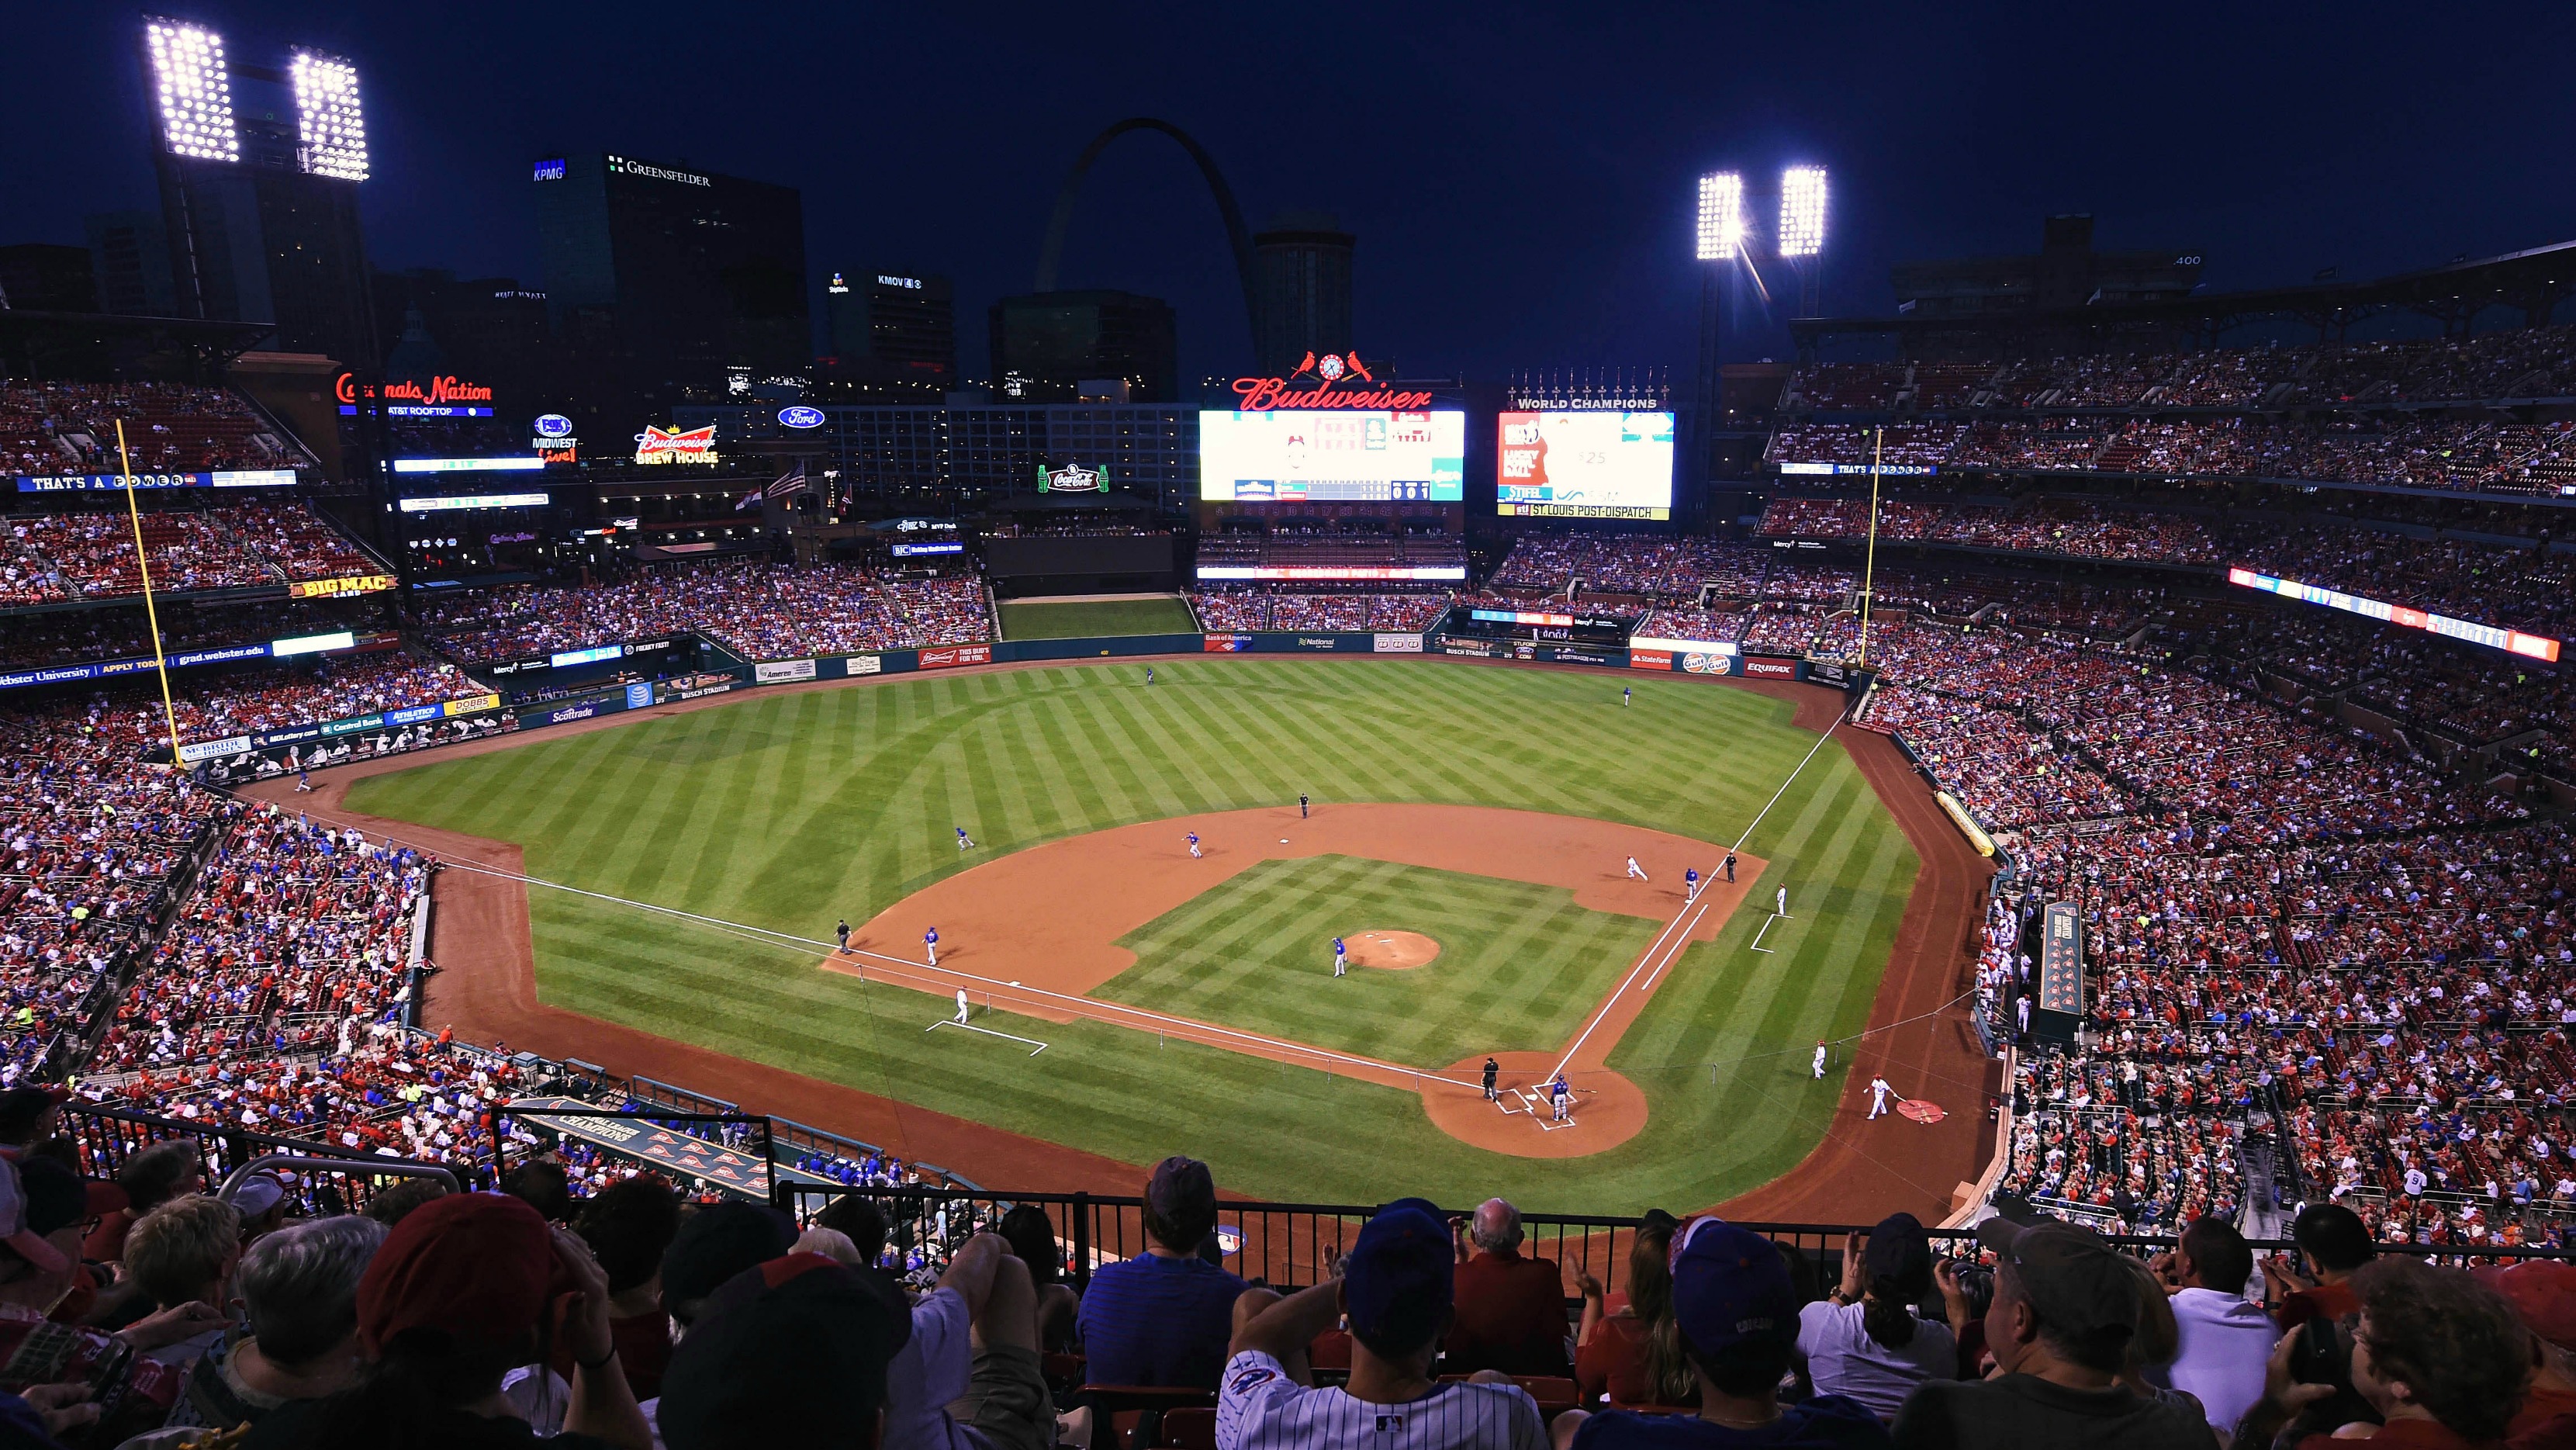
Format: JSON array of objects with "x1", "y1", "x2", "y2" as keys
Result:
[{"x1": 992, "y1": 291, "x2": 1180, "y2": 402}]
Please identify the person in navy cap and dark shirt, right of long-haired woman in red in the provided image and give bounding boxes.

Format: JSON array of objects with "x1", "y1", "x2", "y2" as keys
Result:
[{"x1": 1556, "y1": 1218, "x2": 1888, "y2": 1450}]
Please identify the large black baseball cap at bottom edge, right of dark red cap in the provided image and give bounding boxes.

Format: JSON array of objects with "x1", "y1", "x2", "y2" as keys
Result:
[{"x1": 657, "y1": 1254, "x2": 912, "y2": 1450}]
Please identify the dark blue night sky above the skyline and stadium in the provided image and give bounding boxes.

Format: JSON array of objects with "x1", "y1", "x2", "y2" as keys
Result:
[{"x1": 0, "y1": 0, "x2": 2576, "y2": 379}]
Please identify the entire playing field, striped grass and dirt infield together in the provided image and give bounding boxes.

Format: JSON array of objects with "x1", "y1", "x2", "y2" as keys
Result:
[{"x1": 345, "y1": 657, "x2": 1948, "y2": 1210}]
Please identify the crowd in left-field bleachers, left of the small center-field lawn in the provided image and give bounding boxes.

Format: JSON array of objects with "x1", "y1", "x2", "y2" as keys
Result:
[{"x1": 420, "y1": 562, "x2": 992, "y2": 662}]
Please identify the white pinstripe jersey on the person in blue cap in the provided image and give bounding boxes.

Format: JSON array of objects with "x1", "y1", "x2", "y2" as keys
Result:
[{"x1": 1216, "y1": 1350, "x2": 1548, "y2": 1450}]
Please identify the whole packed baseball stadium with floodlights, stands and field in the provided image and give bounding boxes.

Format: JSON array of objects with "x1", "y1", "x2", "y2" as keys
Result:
[{"x1": 0, "y1": 16, "x2": 2576, "y2": 1450}]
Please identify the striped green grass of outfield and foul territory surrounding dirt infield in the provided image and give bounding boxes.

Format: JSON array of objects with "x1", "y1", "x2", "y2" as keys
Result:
[{"x1": 351, "y1": 657, "x2": 1917, "y2": 1210}]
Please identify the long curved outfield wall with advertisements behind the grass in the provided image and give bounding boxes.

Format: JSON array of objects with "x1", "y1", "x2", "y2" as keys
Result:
[{"x1": 195, "y1": 631, "x2": 1857, "y2": 783}]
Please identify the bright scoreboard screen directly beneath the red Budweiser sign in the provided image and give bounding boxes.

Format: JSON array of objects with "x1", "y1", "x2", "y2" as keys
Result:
[{"x1": 1198, "y1": 410, "x2": 1466, "y2": 502}]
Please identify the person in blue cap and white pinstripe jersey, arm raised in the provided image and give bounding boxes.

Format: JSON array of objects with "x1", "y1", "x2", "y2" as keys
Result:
[{"x1": 1216, "y1": 1198, "x2": 1548, "y2": 1450}]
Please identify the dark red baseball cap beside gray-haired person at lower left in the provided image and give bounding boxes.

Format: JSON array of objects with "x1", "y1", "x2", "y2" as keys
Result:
[{"x1": 358, "y1": 1192, "x2": 556, "y2": 1357}]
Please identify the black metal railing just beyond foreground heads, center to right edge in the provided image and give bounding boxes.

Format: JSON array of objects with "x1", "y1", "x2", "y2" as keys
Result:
[{"x1": 778, "y1": 1182, "x2": 2576, "y2": 1290}]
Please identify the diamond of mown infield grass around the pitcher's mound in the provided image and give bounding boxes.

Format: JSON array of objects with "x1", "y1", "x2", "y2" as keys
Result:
[{"x1": 1092, "y1": 855, "x2": 1661, "y2": 1066}]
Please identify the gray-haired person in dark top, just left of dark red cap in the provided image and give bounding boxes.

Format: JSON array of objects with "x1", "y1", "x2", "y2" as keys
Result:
[{"x1": 147, "y1": 1216, "x2": 386, "y2": 1445}]
